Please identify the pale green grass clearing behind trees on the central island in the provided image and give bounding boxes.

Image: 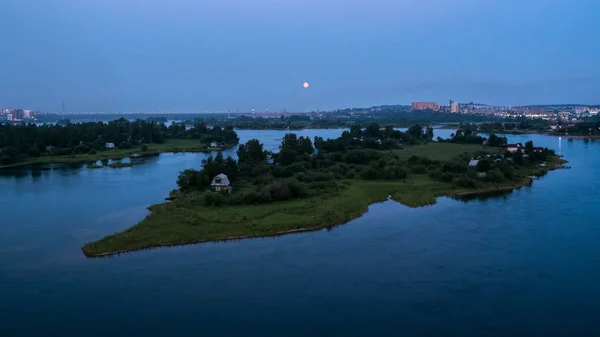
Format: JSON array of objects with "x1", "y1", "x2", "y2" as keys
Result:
[{"x1": 392, "y1": 142, "x2": 492, "y2": 161}]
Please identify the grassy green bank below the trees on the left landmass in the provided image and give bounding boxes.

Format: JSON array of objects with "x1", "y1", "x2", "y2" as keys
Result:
[{"x1": 0, "y1": 139, "x2": 236, "y2": 169}]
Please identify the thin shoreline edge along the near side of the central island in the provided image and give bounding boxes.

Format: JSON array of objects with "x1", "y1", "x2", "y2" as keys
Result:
[{"x1": 81, "y1": 168, "x2": 563, "y2": 258}]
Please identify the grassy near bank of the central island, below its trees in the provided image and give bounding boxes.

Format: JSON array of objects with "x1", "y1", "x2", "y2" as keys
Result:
[{"x1": 82, "y1": 158, "x2": 566, "y2": 257}]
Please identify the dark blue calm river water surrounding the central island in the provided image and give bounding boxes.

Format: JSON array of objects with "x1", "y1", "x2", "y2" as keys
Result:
[{"x1": 0, "y1": 130, "x2": 600, "y2": 337}]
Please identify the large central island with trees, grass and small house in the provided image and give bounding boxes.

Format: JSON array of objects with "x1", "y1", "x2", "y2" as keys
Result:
[{"x1": 82, "y1": 123, "x2": 565, "y2": 257}]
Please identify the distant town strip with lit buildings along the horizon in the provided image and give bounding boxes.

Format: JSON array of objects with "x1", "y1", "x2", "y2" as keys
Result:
[{"x1": 0, "y1": 100, "x2": 600, "y2": 123}]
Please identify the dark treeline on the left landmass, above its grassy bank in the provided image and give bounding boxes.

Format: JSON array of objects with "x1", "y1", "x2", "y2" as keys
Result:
[{"x1": 0, "y1": 118, "x2": 239, "y2": 166}]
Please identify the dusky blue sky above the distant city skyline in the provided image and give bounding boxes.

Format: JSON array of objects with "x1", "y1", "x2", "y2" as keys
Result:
[{"x1": 0, "y1": 0, "x2": 600, "y2": 112}]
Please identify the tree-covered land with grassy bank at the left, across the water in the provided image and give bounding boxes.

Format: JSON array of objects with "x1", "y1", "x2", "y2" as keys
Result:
[{"x1": 0, "y1": 118, "x2": 239, "y2": 168}]
